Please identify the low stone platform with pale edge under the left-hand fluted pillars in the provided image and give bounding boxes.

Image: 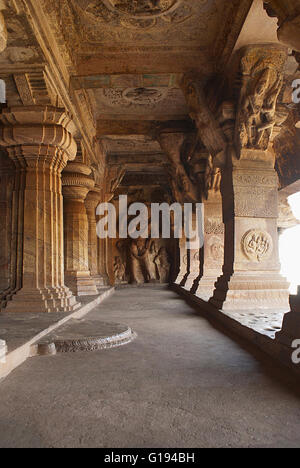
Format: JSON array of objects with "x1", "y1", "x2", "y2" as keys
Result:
[{"x1": 0, "y1": 288, "x2": 115, "y2": 379}]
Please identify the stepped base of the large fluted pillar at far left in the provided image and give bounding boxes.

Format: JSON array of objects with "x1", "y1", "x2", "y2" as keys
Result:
[{"x1": 5, "y1": 287, "x2": 80, "y2": 313}]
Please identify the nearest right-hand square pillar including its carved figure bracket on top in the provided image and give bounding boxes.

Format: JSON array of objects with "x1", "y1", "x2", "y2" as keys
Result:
[{"x1": 211, "y1": 47, "x2": 289, "y2": 310}]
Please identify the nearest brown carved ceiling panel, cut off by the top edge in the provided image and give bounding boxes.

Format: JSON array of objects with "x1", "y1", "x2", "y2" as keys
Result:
[{"x1": 49, "y1": 0, "x2": 226, "y2": 55}]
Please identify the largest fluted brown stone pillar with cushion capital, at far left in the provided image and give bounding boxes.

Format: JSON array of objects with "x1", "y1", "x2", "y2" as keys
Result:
[{"x1": 0, "y1": 106, "x2": 79, "y2": 312}]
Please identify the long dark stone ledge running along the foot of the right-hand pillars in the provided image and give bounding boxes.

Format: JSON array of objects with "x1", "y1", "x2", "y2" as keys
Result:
[{"x1": 171, "y1": 284, "x2": 300, "y2": 377}]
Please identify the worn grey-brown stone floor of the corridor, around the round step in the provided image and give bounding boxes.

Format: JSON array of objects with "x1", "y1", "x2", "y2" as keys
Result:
[{"x1": 0, "y1": 288, "x2": 300, "y2": 448}]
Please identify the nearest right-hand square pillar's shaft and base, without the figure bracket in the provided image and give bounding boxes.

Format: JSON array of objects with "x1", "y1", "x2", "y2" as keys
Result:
[{"x1": 212, "y1": 150, "x2": 289, "y2": 310}]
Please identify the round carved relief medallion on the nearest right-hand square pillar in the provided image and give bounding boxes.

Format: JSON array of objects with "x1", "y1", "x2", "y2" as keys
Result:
[{"x1": 242, "y1": 229, "x2": 273, "y2": 263}]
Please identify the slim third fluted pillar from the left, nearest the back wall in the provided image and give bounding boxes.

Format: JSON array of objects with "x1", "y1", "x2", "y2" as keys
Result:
[{"x1": 85, "y1": 188, "x2": 106, "y2": 288}]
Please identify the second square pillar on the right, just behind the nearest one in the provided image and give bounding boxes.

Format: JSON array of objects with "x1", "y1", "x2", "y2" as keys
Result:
[{"x1": 195, "y1": 191, "x2": 225, "y2": 301}]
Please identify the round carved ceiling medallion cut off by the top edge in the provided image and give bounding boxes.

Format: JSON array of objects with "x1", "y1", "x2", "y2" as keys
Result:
[{"x1": 103, "y1": 0, "x2": 181, "y2": 19}]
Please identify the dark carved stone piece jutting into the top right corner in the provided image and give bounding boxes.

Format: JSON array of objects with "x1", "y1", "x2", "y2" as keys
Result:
[{"x1": 264, "y1": 0, "x2": 300, "y2": 52}]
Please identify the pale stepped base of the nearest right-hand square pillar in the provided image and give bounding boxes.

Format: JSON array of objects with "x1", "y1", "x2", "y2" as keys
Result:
[{"x1": 209, "y1": 272, "x2": 290, "y2": 311}]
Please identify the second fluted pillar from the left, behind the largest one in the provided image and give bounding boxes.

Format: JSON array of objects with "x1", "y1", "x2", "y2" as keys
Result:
[{"x1": 62, "y1": 162, "x2": 98, "y2": 296}]
